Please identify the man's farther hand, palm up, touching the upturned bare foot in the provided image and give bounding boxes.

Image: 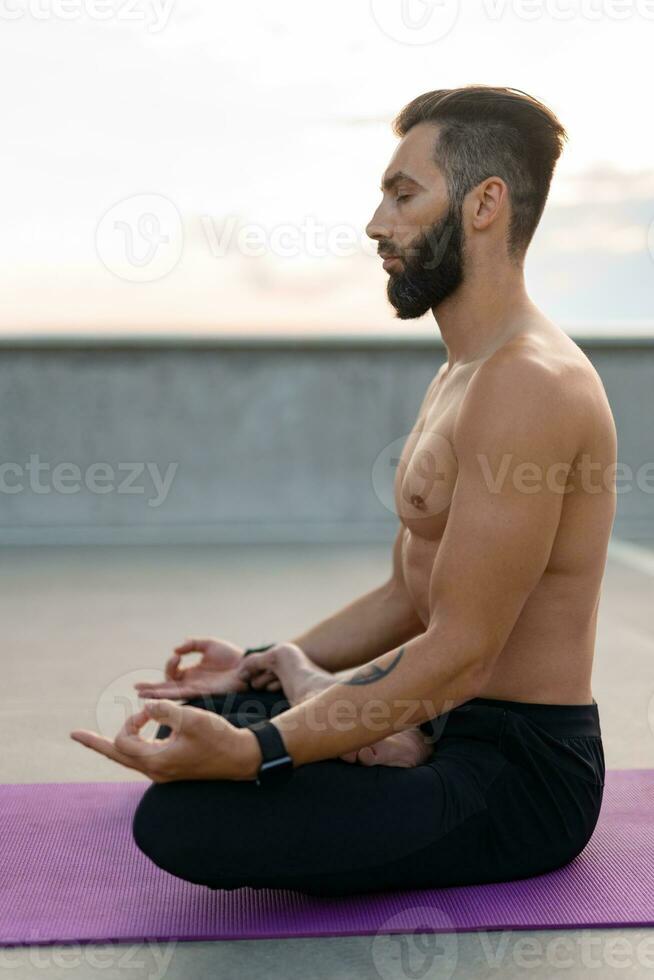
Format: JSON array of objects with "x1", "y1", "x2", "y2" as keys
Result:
[{"x1": 134, "y1": 636, "x2": 280, "y2": 698}]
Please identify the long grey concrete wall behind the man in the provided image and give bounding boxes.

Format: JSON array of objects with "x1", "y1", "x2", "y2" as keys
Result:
[{"x1": 0, "y1": 337, "x2": 654, "y2": 544}]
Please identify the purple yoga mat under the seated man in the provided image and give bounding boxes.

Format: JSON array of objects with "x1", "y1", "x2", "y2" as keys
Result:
[{"x1": 0, "y1": 769, "x2": 654, "y2": 946}]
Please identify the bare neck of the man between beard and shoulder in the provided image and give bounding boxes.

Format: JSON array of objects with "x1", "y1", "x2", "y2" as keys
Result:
[{"x1": 432, "y1": 255, "x2": 536, "y2": 370}]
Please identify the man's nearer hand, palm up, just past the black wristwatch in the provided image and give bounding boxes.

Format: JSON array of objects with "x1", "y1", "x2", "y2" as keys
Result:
[{"x1": 70, "y1": 700, "x2": 261, "y2": 783}]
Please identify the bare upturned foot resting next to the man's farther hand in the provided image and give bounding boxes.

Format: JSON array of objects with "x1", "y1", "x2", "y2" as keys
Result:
[{"x1": 238, "y1": 643, "x2": 337, "y2": 705}]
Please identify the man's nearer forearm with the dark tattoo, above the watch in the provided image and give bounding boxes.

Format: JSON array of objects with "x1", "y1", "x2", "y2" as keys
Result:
[{"x1": 241, "y1": 632, "x2": 483, "y2": 773}]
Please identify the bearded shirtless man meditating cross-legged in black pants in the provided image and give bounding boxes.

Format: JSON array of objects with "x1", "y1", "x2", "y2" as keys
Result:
[{"x1": 72, "y1": 86, "x2": 616, "y2": 895}]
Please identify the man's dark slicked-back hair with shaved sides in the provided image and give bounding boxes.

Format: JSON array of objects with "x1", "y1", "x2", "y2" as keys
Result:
[{"x1": 392, "y1": 85, "x2": 567, "y2": 256}]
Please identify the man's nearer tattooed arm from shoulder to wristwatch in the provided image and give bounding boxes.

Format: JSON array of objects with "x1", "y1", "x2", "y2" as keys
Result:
[{"x1": 242, "y1": 352, "x2": 578, "y2": 775}]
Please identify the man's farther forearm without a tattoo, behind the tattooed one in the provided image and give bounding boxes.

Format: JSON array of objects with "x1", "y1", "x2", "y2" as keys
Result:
[{"x1": 289, "y1": 581, "x2": 425, "y2": 673}]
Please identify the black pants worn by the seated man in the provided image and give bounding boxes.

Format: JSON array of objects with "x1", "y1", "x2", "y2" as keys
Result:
[{"x1": 133, "y1": 689, "x2": 605, "y2": 896}]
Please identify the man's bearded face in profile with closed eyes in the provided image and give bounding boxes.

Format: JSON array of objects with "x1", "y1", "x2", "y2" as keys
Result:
[{"x1": 366, "y1": 123, "x2": 464, "y2": 320}]
